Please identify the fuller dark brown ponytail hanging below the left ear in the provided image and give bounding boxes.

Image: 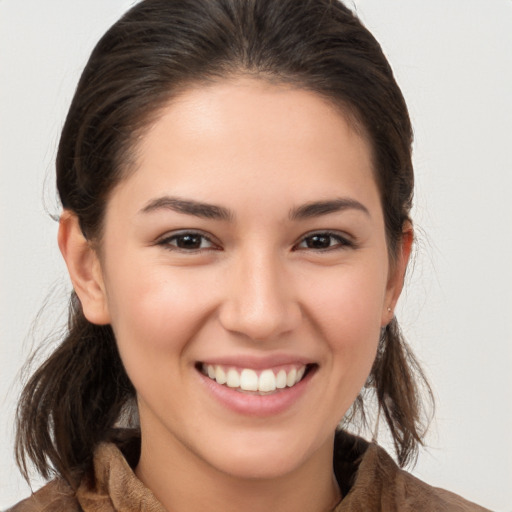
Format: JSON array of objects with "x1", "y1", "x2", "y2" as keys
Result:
[{"x1": 15, "y1": 292, "x2": 135, "y2": 486}]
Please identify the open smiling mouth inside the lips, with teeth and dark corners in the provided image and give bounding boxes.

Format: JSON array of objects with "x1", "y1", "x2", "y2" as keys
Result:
[{"x1": 196, "y1": 363, "x2": 317, "y2": 396}]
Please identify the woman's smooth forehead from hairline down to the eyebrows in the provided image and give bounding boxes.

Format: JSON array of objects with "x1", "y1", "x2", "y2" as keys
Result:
[{"x1": 114, "y1": 78, "x2": 382, "y2": 216}]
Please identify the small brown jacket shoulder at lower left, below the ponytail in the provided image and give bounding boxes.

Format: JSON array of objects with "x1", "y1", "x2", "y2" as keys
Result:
[{"x1": 6, "y1": 479, "x2": 82, "y2": 512}]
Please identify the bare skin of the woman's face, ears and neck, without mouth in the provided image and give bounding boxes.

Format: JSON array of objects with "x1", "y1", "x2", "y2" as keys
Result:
[{"x1": 59, "y1": 78, "x2": 412, "y2": 512}]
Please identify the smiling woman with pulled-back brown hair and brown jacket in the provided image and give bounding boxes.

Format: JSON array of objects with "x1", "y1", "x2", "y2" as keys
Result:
[{"x1": 9, "y1": 0, "x2": 492, "y2": 512}]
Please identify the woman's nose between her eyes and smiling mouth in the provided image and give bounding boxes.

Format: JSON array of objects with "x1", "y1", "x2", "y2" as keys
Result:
[{"x1": 219, "y1": 247, "x2": 302, "y2": 341}]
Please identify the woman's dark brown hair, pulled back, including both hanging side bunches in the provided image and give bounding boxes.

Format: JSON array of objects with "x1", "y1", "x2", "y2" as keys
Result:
[{"x1": 16, "y1": 0, "x2": 430, "y2": 484}]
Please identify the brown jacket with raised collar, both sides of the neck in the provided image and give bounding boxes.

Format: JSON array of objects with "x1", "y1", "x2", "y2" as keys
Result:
[{"x1": 8, "y1": 433, "x2": 489, "y2": 512}]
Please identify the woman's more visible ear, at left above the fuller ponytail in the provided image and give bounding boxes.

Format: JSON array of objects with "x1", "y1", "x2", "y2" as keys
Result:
[{"x1": 58, "y1": 210, "x2": 110, "y2": 325}]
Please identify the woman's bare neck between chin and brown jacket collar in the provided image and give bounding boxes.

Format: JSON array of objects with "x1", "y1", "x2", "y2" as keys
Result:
[{"x1": 135, "y1": 428, "x2": 341, "y2": 512}]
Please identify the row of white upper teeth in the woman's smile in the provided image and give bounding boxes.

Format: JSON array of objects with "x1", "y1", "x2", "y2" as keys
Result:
[{"x1": 202, "y1": 364, "x2": 306, "y2": 393}]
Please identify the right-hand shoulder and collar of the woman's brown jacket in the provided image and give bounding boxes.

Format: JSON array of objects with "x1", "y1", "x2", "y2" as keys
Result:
[{"x1": 336, "y1": 435, "x2": 489, "y2": 512}]
